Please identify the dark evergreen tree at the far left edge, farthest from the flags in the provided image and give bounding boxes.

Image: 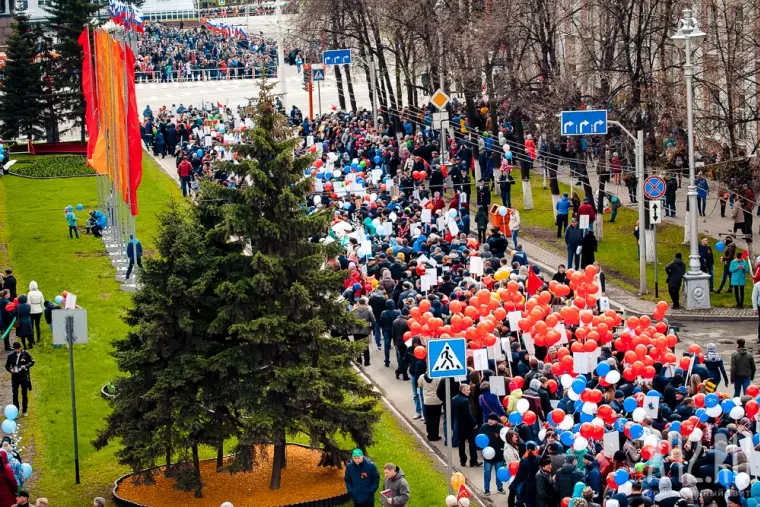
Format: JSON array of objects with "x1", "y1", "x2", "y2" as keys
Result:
[{"x1": 0, "y1": 12, "x2": 45, "y2": 140}]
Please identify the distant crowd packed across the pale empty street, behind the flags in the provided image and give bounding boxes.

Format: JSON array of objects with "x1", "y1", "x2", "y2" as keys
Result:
[{"x1": 135, "y1": 21, "x2": 277, "y2": 83}]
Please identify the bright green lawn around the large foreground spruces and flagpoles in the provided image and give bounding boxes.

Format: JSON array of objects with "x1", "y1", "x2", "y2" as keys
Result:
[{"x1": 0, "y1": 157, "x2": 454, "y2": 507}]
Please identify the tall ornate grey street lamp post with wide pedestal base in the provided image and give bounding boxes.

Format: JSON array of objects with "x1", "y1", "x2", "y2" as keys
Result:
[{"x1": 671, "y1": 8, "x2": 710, "y2": 310}]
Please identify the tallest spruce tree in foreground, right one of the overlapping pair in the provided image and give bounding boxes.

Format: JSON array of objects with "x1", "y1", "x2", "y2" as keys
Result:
[{"x1": 200, "y1": 85, "x2": 379, "y2": 489}]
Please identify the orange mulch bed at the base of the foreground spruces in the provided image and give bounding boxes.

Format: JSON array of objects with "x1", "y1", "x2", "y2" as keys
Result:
[{"x1": 116, "y1": 445, "x2": 346, "y2": 507}]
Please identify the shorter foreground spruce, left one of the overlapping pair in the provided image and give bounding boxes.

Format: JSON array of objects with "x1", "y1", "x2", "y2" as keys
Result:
[{"x1": 93, "y1": 203, "x2": 242, "y2": 497}]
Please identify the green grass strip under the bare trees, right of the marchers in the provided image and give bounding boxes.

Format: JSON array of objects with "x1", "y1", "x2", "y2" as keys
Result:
[{"x1": 498, "y1": 178, "x2": 752, "y2": 307}]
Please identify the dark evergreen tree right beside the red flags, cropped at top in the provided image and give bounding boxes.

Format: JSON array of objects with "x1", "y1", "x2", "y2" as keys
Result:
[{"x1": 45, "y1": 0, "x2": 105, "y2": 141}]
